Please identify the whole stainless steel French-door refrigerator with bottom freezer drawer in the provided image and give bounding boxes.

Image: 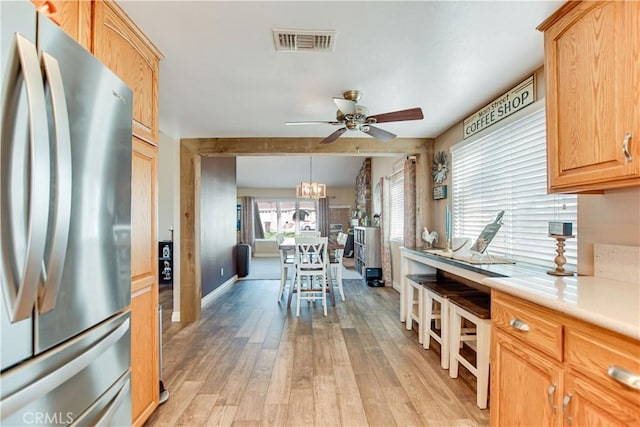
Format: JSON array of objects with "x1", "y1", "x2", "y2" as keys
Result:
[{"x1": 0, "y1": 0, "x2": 132, "y2": 426}]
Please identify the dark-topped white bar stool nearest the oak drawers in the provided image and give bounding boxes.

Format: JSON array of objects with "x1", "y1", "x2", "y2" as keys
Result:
[{"x1": 449, "y1": 292, "x2": 491, "y2": 409}]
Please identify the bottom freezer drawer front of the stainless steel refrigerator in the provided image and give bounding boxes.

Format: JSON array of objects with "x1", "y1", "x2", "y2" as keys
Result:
[{"x1": 0, "y1": 312, "x2": 131, "y2": 426}]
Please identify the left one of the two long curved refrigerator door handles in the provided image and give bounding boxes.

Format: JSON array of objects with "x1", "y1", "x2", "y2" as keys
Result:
[{"x1": 0, "y1": 33, "x2": 50, "y2": 322}]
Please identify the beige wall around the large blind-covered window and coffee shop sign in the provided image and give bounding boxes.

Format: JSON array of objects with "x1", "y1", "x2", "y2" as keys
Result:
[{"x1": 427, "y1": 68, "x2": 640, "y2": 275}]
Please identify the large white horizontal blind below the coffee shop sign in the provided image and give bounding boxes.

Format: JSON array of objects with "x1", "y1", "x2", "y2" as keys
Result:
[{"x1": 451, "y1": 109, "x2": 577, "y2": 268}]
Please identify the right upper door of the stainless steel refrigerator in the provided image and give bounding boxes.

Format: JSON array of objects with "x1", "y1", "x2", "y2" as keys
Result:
[{"x1": 35, "y1": 15, "x2": 132, "y2": 353}]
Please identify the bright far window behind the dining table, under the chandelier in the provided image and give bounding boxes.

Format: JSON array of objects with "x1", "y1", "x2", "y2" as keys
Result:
[{"x1": 256, "y1": 199, "x2": 317, "y2": 240}]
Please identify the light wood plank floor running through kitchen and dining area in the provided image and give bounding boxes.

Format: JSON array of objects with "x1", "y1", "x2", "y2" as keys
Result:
[{"x1": 146, "y1": 280, "x2": 489, "y2": 426}]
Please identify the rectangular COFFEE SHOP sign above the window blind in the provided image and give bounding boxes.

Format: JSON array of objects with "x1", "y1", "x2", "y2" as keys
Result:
[{"x1": 463, "y1": 74, "x2": 536, "y2": 139}]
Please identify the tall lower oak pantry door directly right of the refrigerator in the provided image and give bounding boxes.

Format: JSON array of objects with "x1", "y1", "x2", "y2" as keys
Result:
[{"x1": 131, "y1": 137, "x2": 160, "y2": 426}]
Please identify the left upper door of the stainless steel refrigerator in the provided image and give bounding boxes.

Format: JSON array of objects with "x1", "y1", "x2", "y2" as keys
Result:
[{"x1": 0, "y1": 1, "x2": 39, "y2": 371}]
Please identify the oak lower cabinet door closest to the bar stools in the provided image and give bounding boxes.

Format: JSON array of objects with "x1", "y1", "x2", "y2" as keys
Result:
[{"x1": 490, "y1": 327, "x2": 562, "y2": 427}]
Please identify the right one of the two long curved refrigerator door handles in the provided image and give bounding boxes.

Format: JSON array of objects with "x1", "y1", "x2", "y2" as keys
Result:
[{"x1": 38, "y1": 52, "x2": 72, "y2": 313}]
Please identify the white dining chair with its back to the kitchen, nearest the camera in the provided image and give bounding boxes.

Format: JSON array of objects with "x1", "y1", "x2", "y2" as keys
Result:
[{"x1": 294, "y1": 237, "x2": 329, "y2": 316}]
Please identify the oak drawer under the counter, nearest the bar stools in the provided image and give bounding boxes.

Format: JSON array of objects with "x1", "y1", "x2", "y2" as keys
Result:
[{"x1": 491, "y1": 291, "x2": 563, "y2": 361}]
